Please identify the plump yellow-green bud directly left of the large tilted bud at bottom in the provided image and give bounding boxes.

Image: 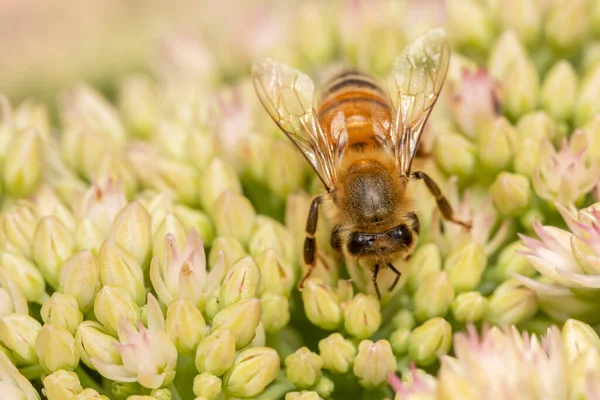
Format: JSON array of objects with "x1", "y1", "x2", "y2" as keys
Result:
[{"x1": 195, "y1": 329, "x2": 235, "y2": 376}]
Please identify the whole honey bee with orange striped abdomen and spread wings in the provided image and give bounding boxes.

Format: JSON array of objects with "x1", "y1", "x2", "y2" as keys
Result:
[{"x1": 252, "y1": 29, "x2": 470, "y2": 298}]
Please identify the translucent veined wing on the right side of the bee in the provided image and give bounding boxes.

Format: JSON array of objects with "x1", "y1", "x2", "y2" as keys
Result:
[{"x1": 390, "y1": 29, "x2": 450, "y2": 175}]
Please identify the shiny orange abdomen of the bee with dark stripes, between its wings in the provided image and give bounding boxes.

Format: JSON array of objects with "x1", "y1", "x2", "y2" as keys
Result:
[{"x1": 319, "y1": 71, "x2": 392, "y2": 148}]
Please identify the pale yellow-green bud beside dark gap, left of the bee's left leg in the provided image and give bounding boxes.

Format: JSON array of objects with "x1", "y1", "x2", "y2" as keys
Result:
[{"x1": 212, "y1": 190, "x2": 256, "y2": 243}]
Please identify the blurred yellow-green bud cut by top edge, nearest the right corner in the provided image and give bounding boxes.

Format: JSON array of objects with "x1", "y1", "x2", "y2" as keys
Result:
[{"x1": 544, "y1": 0, "x2": 590, "y2": 51}]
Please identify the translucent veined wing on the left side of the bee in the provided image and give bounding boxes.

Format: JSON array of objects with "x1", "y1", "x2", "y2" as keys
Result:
[{"x1": 252, "y1": 59, "x2": 345, "y2": 190}]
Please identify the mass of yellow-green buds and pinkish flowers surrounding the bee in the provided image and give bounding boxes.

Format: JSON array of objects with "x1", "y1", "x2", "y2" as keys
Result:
[{"x1": 0, "y1": 0, "x2": 600, "y2": 400}]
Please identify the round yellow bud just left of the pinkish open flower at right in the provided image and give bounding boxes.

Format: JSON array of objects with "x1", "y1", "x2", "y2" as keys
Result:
[{"x1": 490, "y1": 172, "x2": 531, "y2": 217}]
